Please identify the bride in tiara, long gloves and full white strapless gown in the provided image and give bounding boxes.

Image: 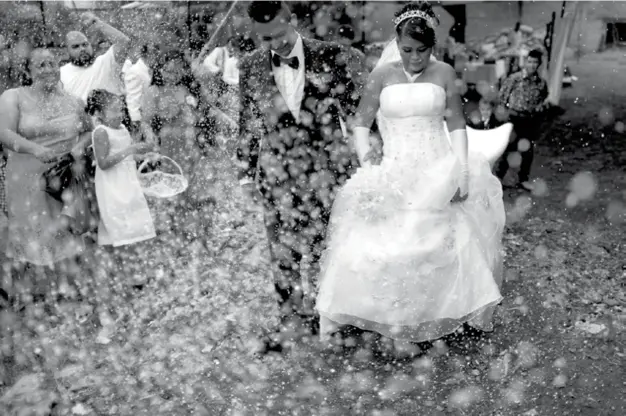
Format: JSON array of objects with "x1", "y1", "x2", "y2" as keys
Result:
[{"x1": 317, "y1": 2, "x2": 505, "y2": 342}]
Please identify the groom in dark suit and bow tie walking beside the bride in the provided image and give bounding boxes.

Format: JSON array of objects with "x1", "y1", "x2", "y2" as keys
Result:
[{"x1": 237, "y1": 1, "x2": 367, "y2": 352}]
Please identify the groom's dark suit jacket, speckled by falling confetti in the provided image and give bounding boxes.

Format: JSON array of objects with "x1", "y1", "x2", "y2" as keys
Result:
[{"x1": 237, "y1": 38, "x2": 367, "y2": 209}]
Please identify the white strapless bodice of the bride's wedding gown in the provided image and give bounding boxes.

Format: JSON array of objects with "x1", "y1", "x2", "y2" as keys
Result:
[{"x1": 378, "y1": 82, "x2": 451, "y2": 167}]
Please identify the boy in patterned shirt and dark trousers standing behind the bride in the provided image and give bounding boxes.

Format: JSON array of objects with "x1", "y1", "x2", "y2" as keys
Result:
[{"x1": 496, "y1": 49, "x2": 550, "y2": 191}]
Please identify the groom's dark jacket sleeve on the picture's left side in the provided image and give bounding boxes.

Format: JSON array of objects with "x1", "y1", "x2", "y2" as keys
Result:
[{"x1": 237, "y1": 59, "x2": 263, "y2": 185}]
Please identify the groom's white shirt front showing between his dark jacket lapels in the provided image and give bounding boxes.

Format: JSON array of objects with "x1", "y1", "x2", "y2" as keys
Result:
[{"x1": 272, "y1": 35, "x2": 305, "y2": 121}]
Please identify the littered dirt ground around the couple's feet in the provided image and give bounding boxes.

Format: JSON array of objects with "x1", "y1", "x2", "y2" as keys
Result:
[{"x1": 0, "y1": 51, "x2": 626, "y2": 416}]
